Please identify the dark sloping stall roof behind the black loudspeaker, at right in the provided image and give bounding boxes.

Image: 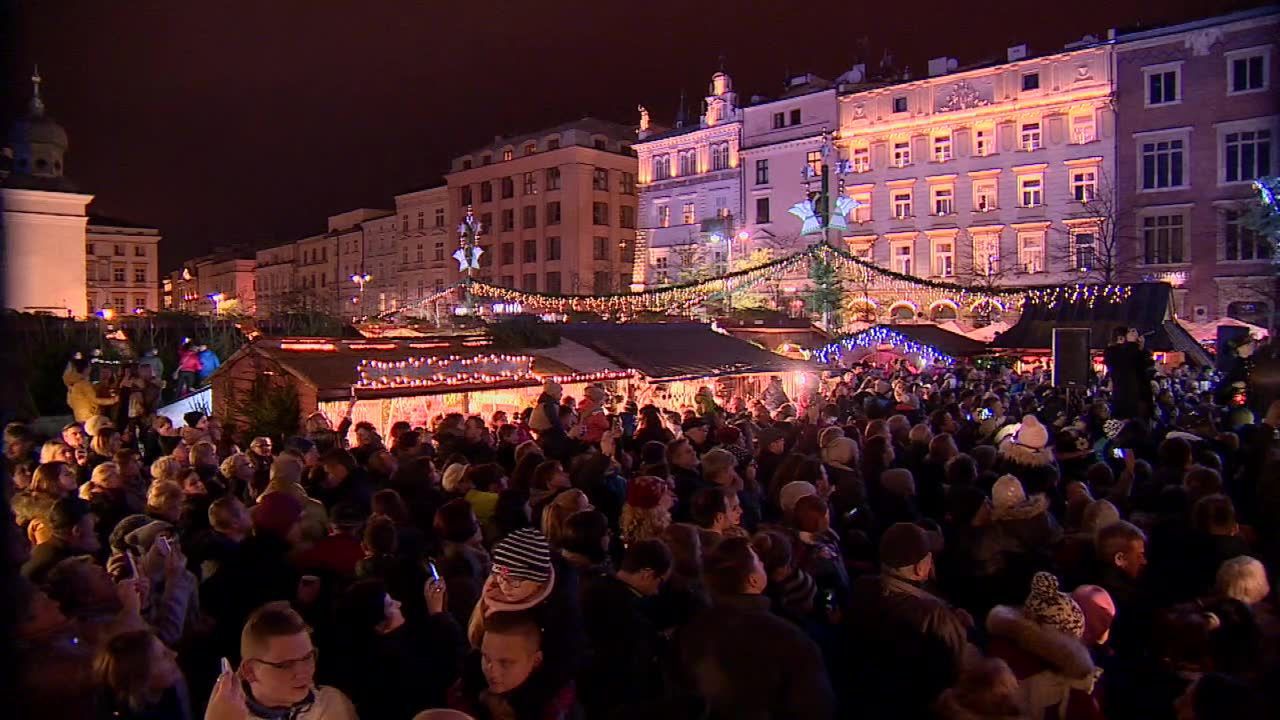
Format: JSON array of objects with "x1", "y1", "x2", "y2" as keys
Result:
[{"x1": 991, "y1": 283, "x2": 1210, "y2": 365}]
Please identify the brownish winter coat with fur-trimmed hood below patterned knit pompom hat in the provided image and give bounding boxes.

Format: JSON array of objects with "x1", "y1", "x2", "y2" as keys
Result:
[{"x1": 987, "y1": 605, "x2": 1102, "y2": 720}]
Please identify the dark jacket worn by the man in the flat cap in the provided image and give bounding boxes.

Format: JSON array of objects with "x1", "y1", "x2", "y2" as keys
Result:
[{"x1": 847, "y1": 571, "x2": 966, "y2": 717}]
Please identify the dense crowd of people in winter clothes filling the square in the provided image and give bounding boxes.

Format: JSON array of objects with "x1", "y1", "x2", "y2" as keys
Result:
[{"x1": 5, "y1": 333, "x2": 1280, "y2": 720}]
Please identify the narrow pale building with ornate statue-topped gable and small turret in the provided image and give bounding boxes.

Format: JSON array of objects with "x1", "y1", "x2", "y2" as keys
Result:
[{"x1": 632, "y1": 72, "x2": 745, "y2": 290}]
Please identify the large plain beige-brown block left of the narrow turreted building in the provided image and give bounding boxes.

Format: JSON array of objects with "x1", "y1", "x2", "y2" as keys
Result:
[{"x1": 450, "y1": 118, "x2": 636, "y2": 295}]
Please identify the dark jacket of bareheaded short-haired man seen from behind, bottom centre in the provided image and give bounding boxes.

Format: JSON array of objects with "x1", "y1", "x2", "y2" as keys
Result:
[{"x1": 676, "y1": 594, "x2": 835, "y2": 720}]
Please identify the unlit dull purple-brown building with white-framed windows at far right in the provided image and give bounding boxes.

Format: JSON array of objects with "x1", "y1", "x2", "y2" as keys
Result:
[{"x1": 1115, "y1": 6, "x2": 1280, "y2": 327}]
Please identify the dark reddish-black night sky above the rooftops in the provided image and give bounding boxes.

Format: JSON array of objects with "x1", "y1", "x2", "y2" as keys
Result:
[{"x1": 4, "y1": 0, "x2": 1261, "y2": 268}]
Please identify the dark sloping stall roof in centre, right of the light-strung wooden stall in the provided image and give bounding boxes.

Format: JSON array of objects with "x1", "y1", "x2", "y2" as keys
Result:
[{"x1": 559, "y1": 323, "x2": 813, "y2": 380}]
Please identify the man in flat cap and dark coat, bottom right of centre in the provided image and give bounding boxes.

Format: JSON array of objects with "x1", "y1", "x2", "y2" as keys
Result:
[{"x1": 846, "y1": 523, "x2": 973, "y2": 719}]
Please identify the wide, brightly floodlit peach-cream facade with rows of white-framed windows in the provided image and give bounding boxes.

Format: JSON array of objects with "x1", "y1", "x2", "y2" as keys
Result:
[{"x1": 837, "y1": 38, "x2": 1120, "y2": 320}]
